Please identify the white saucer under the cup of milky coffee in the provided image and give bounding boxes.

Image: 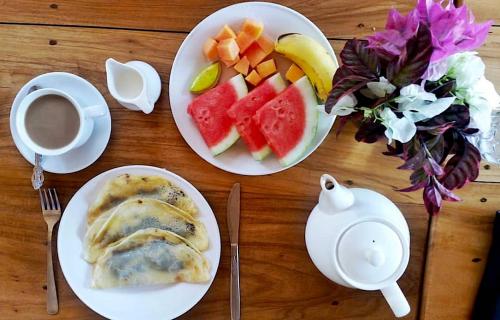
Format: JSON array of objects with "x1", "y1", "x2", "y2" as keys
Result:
[{"x1": 10, "y1": 72, "x2": 111, "y2": 173}]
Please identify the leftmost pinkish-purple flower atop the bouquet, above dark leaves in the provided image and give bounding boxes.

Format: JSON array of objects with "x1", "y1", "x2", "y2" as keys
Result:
[{"x1": 367, "y1": 9, "x2": 419, "y2": 60}]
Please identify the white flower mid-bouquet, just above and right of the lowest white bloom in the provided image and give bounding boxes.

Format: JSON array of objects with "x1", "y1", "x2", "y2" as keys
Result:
[{"x1": 396, "y1": 84, "x2": 455, "y2": 122}]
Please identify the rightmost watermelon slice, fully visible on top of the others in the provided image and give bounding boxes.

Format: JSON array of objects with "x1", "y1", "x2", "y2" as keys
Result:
[{"x1": 254, "y1": 77, "x2": 318, "y2": 166}]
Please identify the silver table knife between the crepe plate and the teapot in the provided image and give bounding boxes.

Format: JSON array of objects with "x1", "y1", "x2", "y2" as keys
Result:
[{"x1": 227, "y1": 183, "x2": 240, "y2": 320}]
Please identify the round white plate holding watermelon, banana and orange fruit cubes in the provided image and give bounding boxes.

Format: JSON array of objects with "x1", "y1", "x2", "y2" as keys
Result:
[{"x1": 169, "y1": 2, "x2": 338, "y2": 175}]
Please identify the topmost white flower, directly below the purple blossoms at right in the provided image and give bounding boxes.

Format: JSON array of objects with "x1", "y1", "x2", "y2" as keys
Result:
[{"x1": 446, "y1": 52, "x2": 485, "y2": 89}]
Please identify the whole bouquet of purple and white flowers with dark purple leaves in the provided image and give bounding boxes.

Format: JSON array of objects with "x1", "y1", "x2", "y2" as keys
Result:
[{"x1": 325, "y1": 0, "x2": 500, "y2": 214}]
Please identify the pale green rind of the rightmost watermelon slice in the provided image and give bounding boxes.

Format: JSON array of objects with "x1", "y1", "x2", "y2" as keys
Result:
[{"x1": 279, "y1": 76, "x2": 318, "y2": 167}]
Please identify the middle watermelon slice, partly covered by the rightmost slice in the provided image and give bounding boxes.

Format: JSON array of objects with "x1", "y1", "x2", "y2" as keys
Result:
[{"x1": 227, "y1": 73, "x2": 286, "y2": 160}]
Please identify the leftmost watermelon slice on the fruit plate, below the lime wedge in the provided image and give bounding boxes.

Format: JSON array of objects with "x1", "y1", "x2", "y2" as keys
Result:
[{"x1": 187, "y1": 74, "x2": 248, "y2": 155}]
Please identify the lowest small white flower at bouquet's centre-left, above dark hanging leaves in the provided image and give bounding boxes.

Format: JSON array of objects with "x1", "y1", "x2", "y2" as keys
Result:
[{"x1": 380, "y1": 108, "x2": 417, "y2": 144}]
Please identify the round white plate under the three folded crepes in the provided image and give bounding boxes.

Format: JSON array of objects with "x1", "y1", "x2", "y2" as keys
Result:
[{"x1": 57, "y1": 166, "x2": 221, "y2": 320}]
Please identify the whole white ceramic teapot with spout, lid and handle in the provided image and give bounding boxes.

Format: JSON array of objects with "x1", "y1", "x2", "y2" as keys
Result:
[{"x1": 305, "y1": 174, "x2": 410, "y2": 317}]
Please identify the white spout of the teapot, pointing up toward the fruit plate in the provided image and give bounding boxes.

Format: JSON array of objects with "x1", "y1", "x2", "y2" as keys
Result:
[{"x1": 319, "y1": 174, "x2": 354, "y2": 213}]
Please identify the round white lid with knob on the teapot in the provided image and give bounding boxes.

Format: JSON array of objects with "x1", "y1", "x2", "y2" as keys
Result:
[{"x1": 333, "y1": 220, "x2": 409, "y2": 290}]
